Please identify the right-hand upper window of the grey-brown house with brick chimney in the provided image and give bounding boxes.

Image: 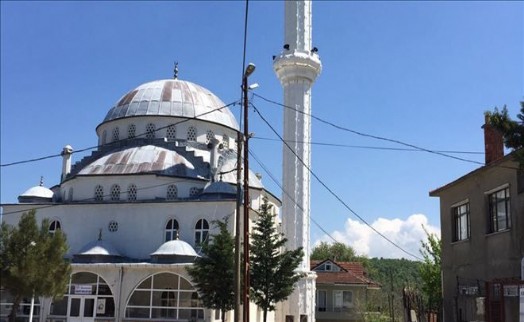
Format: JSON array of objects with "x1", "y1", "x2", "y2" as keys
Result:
[{"x1": 488, "y1": 187, "x2": 511, "y2": 233}]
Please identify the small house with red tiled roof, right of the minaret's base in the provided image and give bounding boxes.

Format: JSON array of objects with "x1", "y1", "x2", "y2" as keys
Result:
[{"x1": 311, "y1": 259, "x2": 380, "y2": 322}]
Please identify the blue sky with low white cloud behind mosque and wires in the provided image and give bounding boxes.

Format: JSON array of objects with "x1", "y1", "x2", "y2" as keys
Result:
[{"x1": 0, "y1": 1, "x2": 524, "y2": 257}]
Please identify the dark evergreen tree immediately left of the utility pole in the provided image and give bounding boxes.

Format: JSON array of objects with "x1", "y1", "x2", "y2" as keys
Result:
[{"x1": 187, "y1": 220, "x2": 235, "y2": 322}]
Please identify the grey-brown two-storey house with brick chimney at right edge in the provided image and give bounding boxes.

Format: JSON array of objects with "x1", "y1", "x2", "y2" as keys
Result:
[{"x1": 429, "y1": 120, "x2": 524, "y2": 322}]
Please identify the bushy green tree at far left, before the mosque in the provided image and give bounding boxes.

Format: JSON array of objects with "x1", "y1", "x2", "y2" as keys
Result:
[{"x1": 0, "y1": 210, "x2": 71, "y2": 322}]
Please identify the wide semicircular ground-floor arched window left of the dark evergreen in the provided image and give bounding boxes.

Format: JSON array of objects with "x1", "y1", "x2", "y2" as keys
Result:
[{"x1": 125, "y1": 273, "x2": 204, "y2": 321}]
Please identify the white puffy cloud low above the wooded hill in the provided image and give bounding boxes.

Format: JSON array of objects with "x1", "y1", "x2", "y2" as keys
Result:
[{"x1": 317, "y1": 214, "x2": 440, "y2": 260}]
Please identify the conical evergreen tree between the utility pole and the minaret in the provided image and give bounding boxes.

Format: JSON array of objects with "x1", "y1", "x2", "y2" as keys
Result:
[{"x1": 250, "y1": 200, "x2": 304, "y2": 322}]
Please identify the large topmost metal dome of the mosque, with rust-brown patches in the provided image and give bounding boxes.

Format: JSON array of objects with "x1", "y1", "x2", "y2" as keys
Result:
[{"x1": 103, "y1": 79, "x2": 239, "y2": 130}]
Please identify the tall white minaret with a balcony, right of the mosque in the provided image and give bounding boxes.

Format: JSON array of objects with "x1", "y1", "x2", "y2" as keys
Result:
[{"x1": 273, "y1": 1, "x2": 322, "y2": 322}]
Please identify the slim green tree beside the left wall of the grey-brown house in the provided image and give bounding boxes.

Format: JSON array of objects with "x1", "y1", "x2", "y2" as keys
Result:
[{"x1": 420, "y1": 228, "x2": 442, "y2": 311}]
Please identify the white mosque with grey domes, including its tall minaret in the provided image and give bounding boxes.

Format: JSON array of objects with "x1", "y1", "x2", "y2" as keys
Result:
[{"x1": 0, "y1": 1, "x2": 321, "y2": 322}]
